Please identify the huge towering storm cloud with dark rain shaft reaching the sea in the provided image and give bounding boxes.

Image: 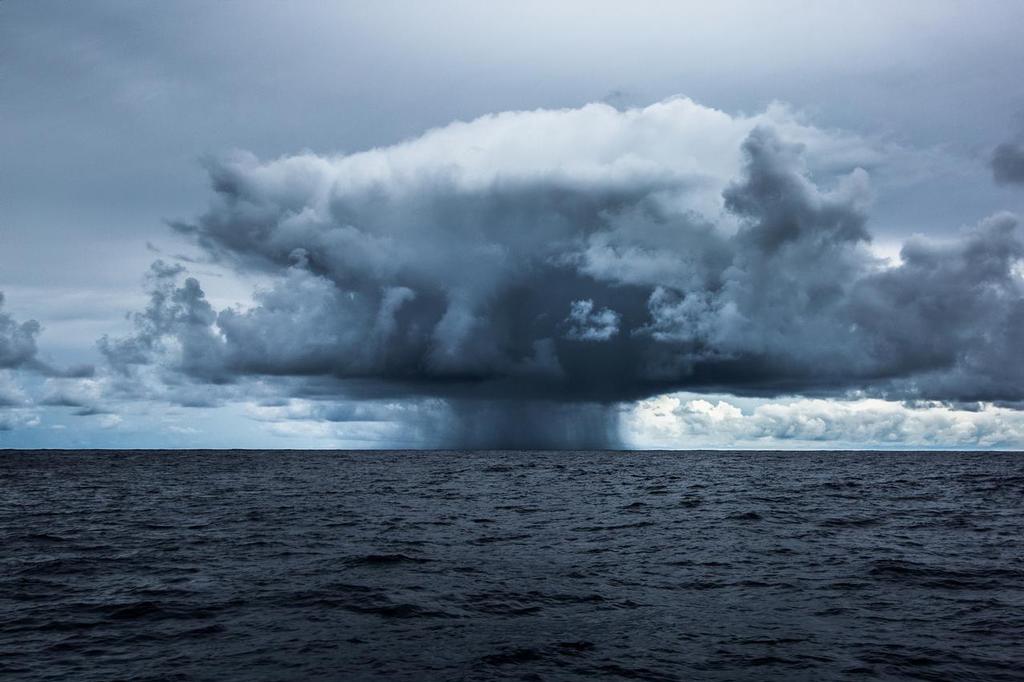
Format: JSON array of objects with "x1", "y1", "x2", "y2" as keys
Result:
[{"x1": 101, "y1": 98, "x2": 1024, "y2": 446}]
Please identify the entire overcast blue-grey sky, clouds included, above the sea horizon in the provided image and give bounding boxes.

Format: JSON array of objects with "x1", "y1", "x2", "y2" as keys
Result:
[{"x1": 0, "y1": 0, "x2": 1024, "y2": 447}]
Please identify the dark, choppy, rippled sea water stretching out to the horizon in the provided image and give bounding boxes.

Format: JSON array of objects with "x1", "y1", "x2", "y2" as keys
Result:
[{"x1": 0, "y1": 452, "x2": 1024, "y2": 680}]
